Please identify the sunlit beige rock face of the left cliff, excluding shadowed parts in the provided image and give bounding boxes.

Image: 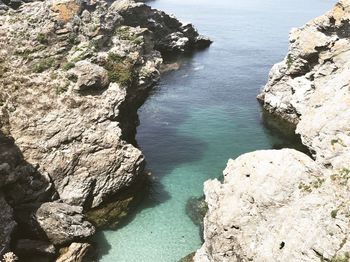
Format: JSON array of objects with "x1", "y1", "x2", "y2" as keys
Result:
[{"x1": 1, "y1": 1, "x2": 156, "y2": 211}]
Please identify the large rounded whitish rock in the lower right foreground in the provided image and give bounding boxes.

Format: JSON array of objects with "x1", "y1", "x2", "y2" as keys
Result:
[{"x1": 194, "y1": 149, "x2": 350, "y2": 262}]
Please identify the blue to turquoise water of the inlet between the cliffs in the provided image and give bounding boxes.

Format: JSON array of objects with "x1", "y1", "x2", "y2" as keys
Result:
[{"x1": 99, "y1": 0, "x2": 335, "y2": 262}]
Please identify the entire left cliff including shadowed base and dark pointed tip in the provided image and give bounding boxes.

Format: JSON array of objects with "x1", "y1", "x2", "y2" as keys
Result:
[{"x1": 0, "y1": 0, "x2": 211, "y2": 261}]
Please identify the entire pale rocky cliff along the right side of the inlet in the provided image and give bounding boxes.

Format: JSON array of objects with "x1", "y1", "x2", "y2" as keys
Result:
[{"x1": 194, "y1": 0, "x2": 350, "y2": 262}]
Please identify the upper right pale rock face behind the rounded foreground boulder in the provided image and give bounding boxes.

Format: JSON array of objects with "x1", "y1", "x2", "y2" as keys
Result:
[{"x1": 259, "y1": 0, "x2": 350, "y2": 170}]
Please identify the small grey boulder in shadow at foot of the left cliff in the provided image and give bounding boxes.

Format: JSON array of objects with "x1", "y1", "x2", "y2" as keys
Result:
[{"x1": 34, "y1": 202, "x2": 95, "y2": 245}]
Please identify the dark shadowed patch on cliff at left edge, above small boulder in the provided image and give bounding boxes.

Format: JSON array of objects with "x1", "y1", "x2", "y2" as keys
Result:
[{"x1": 0, "y1": 129, "x2": 53, "y2": 261}]
